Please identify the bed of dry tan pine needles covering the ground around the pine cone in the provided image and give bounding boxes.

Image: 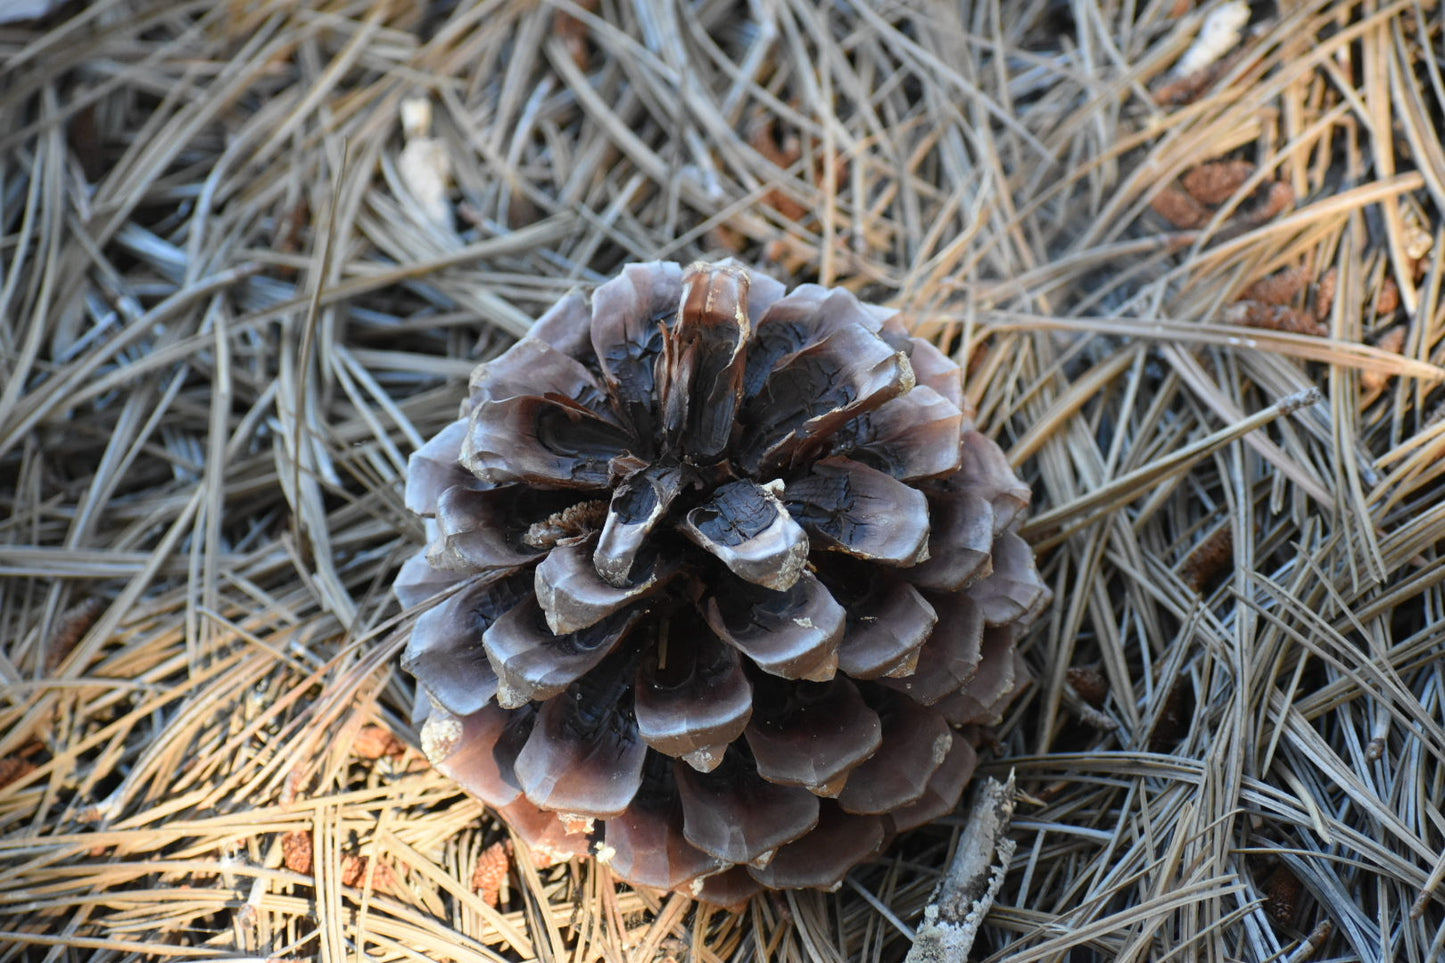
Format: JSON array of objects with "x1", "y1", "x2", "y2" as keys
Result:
[{"x1": 0, "y1": 0, "x2": 1445, "y2": 963}]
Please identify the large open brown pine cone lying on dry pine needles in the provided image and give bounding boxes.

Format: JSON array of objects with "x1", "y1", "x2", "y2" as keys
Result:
[{"x1": 396, "y1": 263, "x2": 1049, "y2": 904}]
